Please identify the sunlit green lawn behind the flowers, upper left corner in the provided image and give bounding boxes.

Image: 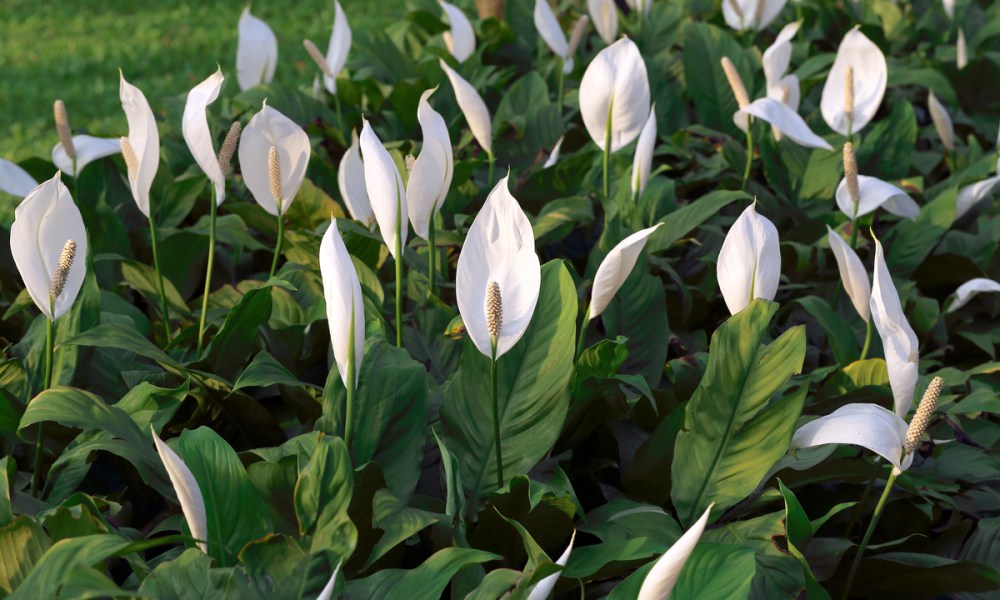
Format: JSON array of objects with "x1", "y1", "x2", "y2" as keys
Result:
[{"x1": 0, "y1": 0, "x2": 404, "y2": 162}]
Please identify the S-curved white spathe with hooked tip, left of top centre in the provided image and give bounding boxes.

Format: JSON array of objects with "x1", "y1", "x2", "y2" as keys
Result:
[{"x1": 406, "y1": 88, "x2": 454, "y2": 239}]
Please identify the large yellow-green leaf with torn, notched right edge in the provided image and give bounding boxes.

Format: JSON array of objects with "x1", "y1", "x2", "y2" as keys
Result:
[{"x1": 671, "y1": 299, "x2": 806, "y2": 526}]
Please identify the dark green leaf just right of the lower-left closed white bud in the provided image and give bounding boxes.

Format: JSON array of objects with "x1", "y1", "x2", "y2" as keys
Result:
[{"x1": 177, "y1": 427, "x2": 271, "y2": 566}]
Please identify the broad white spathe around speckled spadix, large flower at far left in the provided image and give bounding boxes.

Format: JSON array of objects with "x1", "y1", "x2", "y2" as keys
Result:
[{"x1": 10, "y1": 172, "x2": 87, "y2": 319}]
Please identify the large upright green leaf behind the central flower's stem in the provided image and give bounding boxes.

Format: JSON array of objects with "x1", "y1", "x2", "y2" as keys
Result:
[{"x1": 441, "y1": 261, "x2": 577, "y2": 503}]
